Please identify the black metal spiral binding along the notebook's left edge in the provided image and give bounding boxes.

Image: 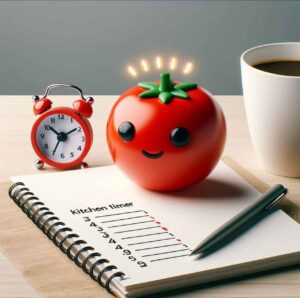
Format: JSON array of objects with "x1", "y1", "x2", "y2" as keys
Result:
[{"x1": 8, "y1": 182, "x2": 125, "y2": 293}]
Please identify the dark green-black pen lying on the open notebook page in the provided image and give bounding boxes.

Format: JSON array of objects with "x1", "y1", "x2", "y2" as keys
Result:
[{"x1": 191, "y1": 184, "x2": 287, "y2": 257}]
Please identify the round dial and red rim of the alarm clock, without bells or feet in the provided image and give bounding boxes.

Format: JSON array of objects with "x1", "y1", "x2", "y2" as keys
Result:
[{"x1": 32, "y1": 108, "x2": 91, "y2": 167}]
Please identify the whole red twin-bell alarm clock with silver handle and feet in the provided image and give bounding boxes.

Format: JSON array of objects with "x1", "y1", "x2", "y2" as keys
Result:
[{"x1": 31, "y1": 84, "x2": 94, "y2": 169}]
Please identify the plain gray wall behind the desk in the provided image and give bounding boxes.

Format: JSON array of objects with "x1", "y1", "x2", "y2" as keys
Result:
[{"x1": 0, "y1": 1, "x2": 300, "y2": 94}]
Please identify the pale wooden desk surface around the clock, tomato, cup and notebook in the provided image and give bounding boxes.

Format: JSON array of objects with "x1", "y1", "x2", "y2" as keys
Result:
[{"x1": 0, "y1": 96, "x2": 300, "y2": 298}]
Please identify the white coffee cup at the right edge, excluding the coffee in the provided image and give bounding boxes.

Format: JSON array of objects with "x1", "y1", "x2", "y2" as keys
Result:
[{"x1": 241, "y1": 42, "x2": 300, "y2": 177}]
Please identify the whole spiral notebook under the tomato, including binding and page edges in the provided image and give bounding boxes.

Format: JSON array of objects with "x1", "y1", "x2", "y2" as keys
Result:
[{"x1": 9, "y1": 162, "x2": 300, "y2": 297}]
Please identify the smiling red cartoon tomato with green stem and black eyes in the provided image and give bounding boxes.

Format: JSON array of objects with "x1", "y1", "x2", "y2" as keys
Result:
[{"x1": 107, "y1": 73, "x2": 226, "y2": 191}]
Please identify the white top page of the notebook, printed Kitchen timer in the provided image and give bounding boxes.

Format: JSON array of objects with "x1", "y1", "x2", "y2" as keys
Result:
[{"x1": 12, "y1": 162, "x2": 300, "y2": 286}]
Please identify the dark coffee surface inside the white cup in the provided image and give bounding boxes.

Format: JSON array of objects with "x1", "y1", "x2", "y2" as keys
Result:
[{"x1": 253, "y1": 60, "x2": 300, "y2": 76}]
